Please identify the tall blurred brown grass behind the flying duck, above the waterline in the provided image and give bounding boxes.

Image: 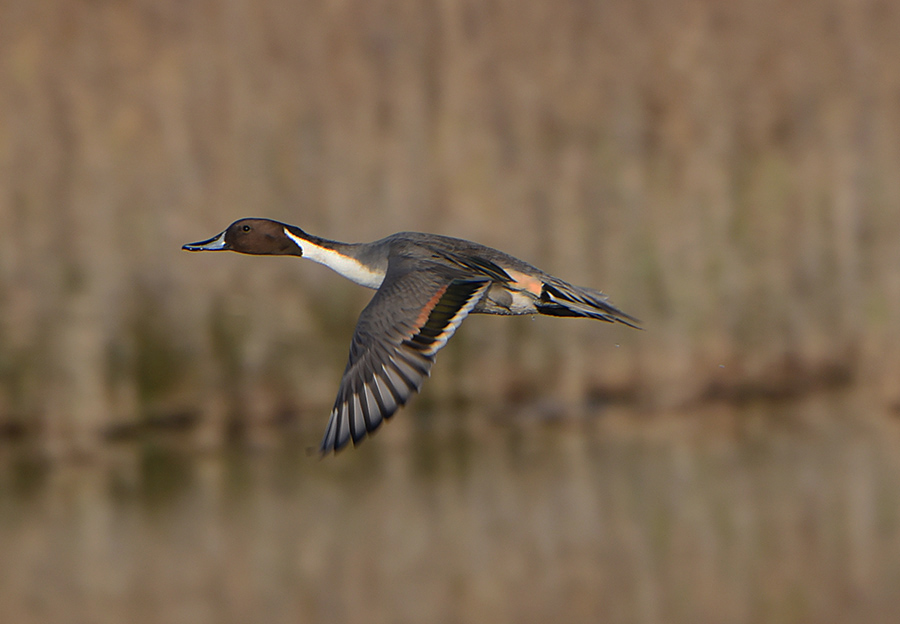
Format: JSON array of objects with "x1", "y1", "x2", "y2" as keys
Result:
[{"x1": 0, "y1": 0, "x2": 900, "y2": 450}]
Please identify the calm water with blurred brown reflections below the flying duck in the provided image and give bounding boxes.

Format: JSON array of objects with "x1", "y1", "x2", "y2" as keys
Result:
[{"x1": 0, "y1": 397, "x2": 900, "y2": 624}]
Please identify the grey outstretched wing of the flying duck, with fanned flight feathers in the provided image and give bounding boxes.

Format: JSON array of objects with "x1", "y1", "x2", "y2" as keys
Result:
[{"x1": 319, "y1": 256, "x2": 491, "y2": 454}]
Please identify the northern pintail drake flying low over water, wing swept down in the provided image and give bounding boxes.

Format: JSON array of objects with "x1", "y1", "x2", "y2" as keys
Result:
[{"x1": 183, "y1": 219, "x2": 639, "y2": 455}]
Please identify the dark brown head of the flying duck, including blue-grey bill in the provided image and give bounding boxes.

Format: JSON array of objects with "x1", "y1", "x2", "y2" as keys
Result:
[{"x1": 182, "y1": 219, "x2": 306, "y2": 256}]
